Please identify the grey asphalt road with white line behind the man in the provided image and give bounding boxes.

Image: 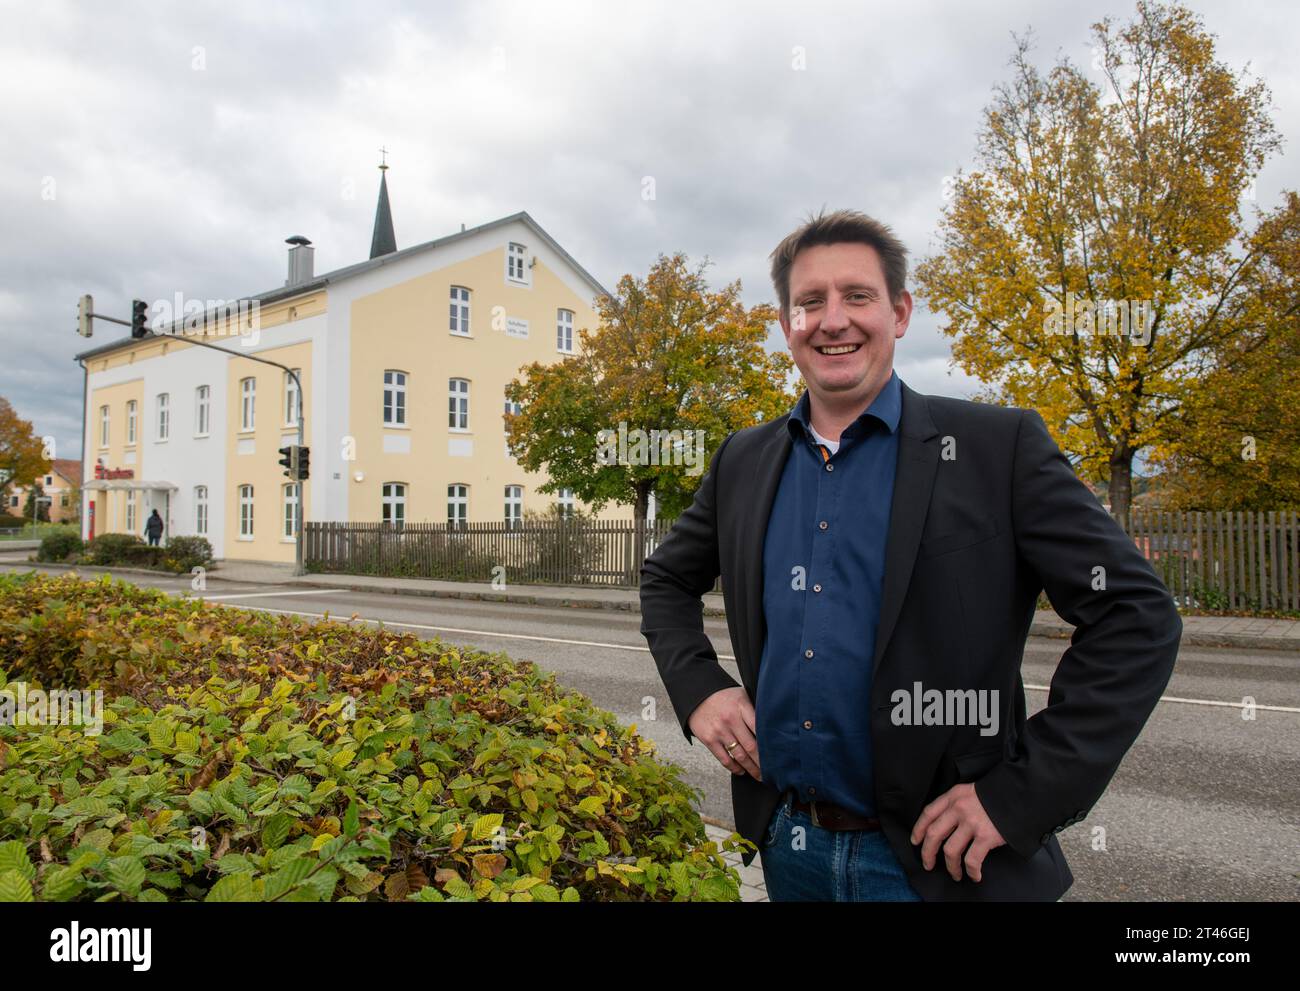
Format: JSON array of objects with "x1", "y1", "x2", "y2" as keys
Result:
[{"x1": 0, "y1": 564, "x2": 1300, "y2": 899}]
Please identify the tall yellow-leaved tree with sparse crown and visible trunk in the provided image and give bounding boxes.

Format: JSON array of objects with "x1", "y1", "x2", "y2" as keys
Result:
[{"x1": 917, "y1": 3, "x2": 1278, "y2": 523}]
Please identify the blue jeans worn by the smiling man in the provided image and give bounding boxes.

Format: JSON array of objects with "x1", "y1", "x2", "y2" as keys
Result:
[{"x1": 759, "y1": 792, "x2": 922, "y2": 901}]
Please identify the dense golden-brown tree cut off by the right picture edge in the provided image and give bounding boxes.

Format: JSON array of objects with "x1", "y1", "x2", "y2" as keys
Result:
[{"x1": 1153, "y1": 192, "x2": 1300, "y2": 510}]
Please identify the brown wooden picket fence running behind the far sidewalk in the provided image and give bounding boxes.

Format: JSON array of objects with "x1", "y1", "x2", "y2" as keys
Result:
[{"x1": 304, "y1": 510, "x2": 1300, "y2": 611}]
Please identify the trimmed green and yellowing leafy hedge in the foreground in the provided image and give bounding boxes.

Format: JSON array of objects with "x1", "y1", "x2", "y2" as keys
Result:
[{"x1": 0, "y1": 574, "x2": 749, "y2": 901}]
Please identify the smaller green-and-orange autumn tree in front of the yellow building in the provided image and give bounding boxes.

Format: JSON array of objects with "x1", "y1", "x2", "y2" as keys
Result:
[{"x1": 504, "y1": 252, "x2": 794, "y2": 522}]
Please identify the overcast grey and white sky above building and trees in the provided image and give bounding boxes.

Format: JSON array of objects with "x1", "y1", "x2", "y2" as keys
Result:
[{"x1": 0, "y1": 0, "x2": 1300, "y2": 458}]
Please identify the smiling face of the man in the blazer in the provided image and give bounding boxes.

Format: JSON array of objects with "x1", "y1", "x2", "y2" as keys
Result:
[{"x1": 781, "y1": 243, "x2": 911, "y2": 406}]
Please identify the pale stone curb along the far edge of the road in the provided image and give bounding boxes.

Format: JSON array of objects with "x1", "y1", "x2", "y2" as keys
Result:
[{"x1": 10, "y1": 561, "x2": 1300, "y2": 653}]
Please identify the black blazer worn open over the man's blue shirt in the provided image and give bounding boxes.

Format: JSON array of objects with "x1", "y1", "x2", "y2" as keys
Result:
[{"x1": 641, "y1": 385, "x2": 1182, "y2": 901}]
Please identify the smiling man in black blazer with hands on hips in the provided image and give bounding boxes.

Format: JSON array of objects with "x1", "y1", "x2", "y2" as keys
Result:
[{"x1": 641, "y1": 211, "x2": 1182, "y2": 901}]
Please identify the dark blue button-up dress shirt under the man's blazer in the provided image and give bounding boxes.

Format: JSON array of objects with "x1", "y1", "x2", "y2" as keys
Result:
[{"x1": 754, "y1": 373, "x2": 902, "y2": 817}]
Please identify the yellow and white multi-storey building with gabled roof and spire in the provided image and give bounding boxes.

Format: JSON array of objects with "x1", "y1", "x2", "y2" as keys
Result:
[{"x1": 77, "y1": 165, "x2": 616, "y2": 562}]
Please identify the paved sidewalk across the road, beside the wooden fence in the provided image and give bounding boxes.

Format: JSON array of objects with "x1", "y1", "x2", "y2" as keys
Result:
[{"x1": 0, "y1": 548, "x2": 1300, "y2": 652}]
